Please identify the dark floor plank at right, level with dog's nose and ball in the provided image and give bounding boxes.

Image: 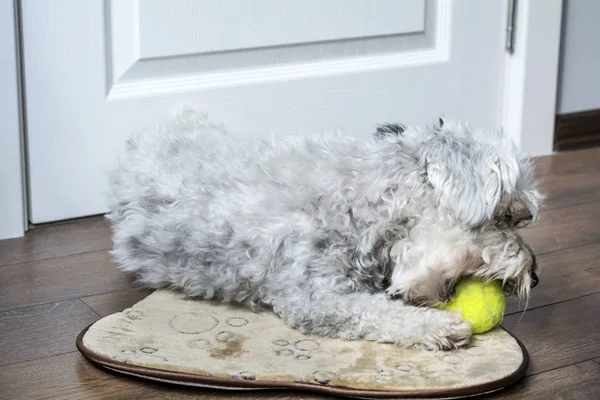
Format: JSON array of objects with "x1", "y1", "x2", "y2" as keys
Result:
[{"x1": 506, "y1": 243, "x2": 600, "y2": 314}]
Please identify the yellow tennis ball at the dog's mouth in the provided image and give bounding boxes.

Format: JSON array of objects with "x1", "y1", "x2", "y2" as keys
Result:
[{"x1": 441, "y1": 278, "x2": 506, "y2": 333}]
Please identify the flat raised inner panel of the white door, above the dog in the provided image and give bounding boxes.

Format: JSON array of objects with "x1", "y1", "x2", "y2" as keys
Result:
[{"x1": 137, "y1": 0, "x2": 425, "y2": 58}]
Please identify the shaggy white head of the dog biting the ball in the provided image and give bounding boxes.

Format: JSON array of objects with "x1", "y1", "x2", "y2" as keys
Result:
[{"x1": 380, "y1": 120, "x2": 542, "y2": 305}]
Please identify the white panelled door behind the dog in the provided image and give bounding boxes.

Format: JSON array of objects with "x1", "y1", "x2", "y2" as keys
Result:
[{"x1": 21, "y1": 0, "x2": 506, "y2": 223}]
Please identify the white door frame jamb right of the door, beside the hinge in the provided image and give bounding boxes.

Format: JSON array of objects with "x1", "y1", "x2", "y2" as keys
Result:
[{"x1": 502, "y1": 0, "x2": 563, "y2": 156}]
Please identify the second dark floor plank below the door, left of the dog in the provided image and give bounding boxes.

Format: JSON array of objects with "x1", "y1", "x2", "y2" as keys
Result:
[{"x1": 0, "y1": 250, "x2": 132, "y2": 310}]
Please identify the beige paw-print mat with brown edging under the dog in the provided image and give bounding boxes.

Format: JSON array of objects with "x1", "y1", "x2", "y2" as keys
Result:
[{"x1": 77, "y1": 291, "x2": 528, "y2": 398}]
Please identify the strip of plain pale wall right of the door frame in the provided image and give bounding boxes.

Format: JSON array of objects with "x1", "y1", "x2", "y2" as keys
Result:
[{"x1": 557, "y1": 0, "x2": 600, "y2": 114}]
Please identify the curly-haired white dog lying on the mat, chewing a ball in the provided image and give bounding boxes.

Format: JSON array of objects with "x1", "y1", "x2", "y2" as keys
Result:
[{"x1": 108, "y1": 112, "x2": 541, "y2": 349}]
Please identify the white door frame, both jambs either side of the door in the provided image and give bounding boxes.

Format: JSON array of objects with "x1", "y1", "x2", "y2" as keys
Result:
[{"x1": 0, "y1": 0, "x2": 563, "y2": 239}]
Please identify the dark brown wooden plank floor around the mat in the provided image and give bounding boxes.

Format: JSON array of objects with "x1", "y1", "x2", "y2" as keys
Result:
[{"x1": 0, "y1": 149, "x2": 600, "y2": 400}]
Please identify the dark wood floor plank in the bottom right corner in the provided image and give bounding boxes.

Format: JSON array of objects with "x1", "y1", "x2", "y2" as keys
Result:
[{"x1": 486, "y1": 361, "x2": 600, "y2": 400}]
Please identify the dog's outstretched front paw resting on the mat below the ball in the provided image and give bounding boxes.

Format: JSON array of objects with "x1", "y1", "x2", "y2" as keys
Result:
[{"x1": 422, "y1": 312, "x2": 472, "y2": 350}]
